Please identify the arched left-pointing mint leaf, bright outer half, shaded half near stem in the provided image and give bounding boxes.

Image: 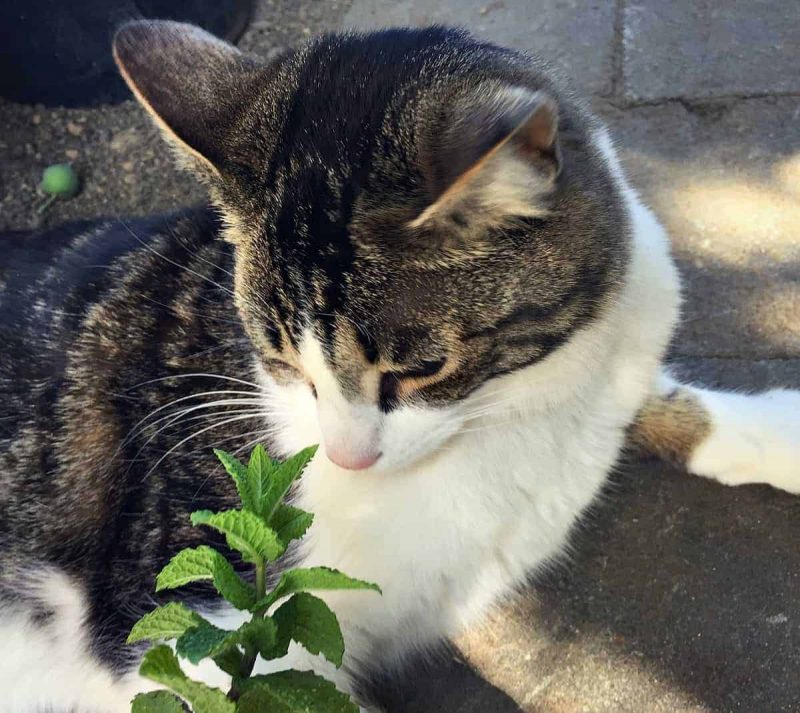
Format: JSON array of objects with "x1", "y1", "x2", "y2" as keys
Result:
[{"x1": 156, "y1": 545, "x2": 256, "y2": 610}]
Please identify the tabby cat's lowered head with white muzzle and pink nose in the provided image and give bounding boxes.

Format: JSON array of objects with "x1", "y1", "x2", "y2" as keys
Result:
[{"x1": 114, "y1": 22, "x2": 627, "y2": 470}]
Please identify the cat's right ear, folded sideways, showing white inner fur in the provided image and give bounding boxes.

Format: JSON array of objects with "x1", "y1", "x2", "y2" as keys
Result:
[{"x1": 411, "y1": 86, "x2": 561, "y2": 228}]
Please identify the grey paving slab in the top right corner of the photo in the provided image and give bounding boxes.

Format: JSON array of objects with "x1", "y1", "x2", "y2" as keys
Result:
[{"x1": 622, "y1": 0, "x2": 800, "y2": 101}]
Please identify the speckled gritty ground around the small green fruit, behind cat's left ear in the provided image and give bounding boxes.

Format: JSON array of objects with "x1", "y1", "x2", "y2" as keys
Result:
[{"x1": 0, "y1": 0, "x2": 350, "y2": 230}]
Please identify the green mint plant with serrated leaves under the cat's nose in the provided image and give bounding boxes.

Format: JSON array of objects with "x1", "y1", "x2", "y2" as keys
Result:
[{"x1": 128, "y1": 446, "x2": 380, "y2": 713}]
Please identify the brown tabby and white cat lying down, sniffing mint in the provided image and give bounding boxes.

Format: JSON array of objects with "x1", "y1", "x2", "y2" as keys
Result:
[{"x1": 0, "y1": 21, "x2": 800, "y2": 712}]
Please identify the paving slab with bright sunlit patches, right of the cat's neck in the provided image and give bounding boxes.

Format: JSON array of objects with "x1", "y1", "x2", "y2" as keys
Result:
[{"x1": 602, "y1": 97, "x2": 800, "y2": 359}]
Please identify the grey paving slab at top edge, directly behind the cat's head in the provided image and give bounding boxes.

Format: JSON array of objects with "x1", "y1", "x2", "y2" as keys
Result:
[{"x1": 343, "y1": 0, "x2": 614, "y2": 95}]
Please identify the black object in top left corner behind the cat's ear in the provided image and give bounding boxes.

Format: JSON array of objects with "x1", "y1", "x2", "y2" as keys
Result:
[{"x1": 0, "y1": 0, "x2": 253, "y2": 107}]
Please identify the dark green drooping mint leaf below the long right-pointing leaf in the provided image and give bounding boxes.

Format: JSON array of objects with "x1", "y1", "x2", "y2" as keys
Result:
[{"x1": 272, "y1": 592, "x2": 344, "y2": 668}]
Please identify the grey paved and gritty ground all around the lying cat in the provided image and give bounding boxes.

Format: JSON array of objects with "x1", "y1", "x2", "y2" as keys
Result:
[{"x1": 0, "y1": 0, "x2": 800, "y2": 713}]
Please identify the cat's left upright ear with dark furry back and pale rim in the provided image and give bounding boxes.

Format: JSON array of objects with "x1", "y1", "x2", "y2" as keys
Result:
[{"x1": 113, "y1": 20, "x2": 261, "y2": 176}]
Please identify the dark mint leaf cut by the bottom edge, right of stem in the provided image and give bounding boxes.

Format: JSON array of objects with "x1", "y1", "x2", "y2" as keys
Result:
[{"x1": 238, "y1": 671, "x2": 358, "y2": 713}]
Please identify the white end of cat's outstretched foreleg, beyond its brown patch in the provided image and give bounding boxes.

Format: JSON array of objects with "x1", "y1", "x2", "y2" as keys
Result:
[{"x1": 688, "y1": 389, "x2": 800, "y2": 494}]
